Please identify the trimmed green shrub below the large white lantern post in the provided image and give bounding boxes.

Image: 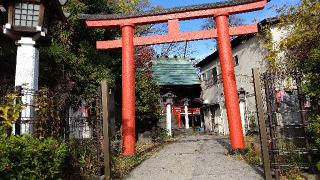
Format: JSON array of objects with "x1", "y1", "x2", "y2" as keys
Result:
[{"x1": 0, "y1": 130, "x2": 69, "y2": 179}]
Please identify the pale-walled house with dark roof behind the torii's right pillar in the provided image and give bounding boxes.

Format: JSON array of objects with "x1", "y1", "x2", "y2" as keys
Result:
[{"x1": 196, "y1": 18, "x2": 286, "y2": 135}]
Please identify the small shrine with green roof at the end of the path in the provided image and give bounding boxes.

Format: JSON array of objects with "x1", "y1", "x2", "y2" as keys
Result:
[{"x1": 152, "y1": 57, "x2": 202, "y2": 135}]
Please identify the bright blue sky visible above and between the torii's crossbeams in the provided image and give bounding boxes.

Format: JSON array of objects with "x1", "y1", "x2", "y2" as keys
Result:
[{"x1": 150, "y1": 0, "x2": 300, "y2": 60}]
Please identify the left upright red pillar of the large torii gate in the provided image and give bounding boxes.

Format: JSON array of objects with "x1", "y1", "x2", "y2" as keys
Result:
[{"x1": 121, "y1": 24, "x2": 135, "y2": 156}]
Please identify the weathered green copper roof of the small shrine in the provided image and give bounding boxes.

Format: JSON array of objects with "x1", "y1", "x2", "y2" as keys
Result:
[{"x1": 152, "y1": 59, "x2": 200, "y2": 85}]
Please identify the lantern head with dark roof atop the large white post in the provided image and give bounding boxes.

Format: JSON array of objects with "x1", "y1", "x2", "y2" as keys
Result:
[{"x1": 0, "y1": 0, "x2": 67, "y2": 40}]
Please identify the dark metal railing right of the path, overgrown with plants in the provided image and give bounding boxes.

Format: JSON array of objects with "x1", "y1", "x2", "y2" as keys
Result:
[{"x1": 254, "y1": 70, "x2": 319, "y2": 180}]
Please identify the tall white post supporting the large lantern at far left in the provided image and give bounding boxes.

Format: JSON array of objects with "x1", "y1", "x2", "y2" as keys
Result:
[{"x1": 13, "y1": 37, "x2": 39, "y2": 134}]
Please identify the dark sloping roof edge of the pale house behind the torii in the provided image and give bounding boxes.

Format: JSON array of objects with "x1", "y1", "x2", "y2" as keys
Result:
[{"x1": 196, "y1": 17, "x2": 279, "y2": 67}]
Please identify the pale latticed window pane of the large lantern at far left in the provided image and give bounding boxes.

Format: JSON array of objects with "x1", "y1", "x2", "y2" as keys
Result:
[{"x1": 14, "y1": 3, "x2": 40, "y2": 27}]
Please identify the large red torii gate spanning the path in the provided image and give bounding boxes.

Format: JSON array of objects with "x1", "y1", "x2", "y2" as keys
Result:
[{"x1": 82, "y1": 0, "x2": 268, "y2": 156}]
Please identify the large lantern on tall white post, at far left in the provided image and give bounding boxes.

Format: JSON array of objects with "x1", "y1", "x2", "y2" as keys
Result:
[{"x1": 0, "y1": 0, "x2": 66, "y2": 134}]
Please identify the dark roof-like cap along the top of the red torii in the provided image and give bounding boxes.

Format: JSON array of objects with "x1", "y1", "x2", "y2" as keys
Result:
[{"x1": 79, "y1": 0, "x2": 270, "y2": 20}]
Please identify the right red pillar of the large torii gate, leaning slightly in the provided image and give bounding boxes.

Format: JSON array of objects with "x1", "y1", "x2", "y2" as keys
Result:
[{"x1": 215, "y1": 14, "x2": 244, "y2": 149}]
